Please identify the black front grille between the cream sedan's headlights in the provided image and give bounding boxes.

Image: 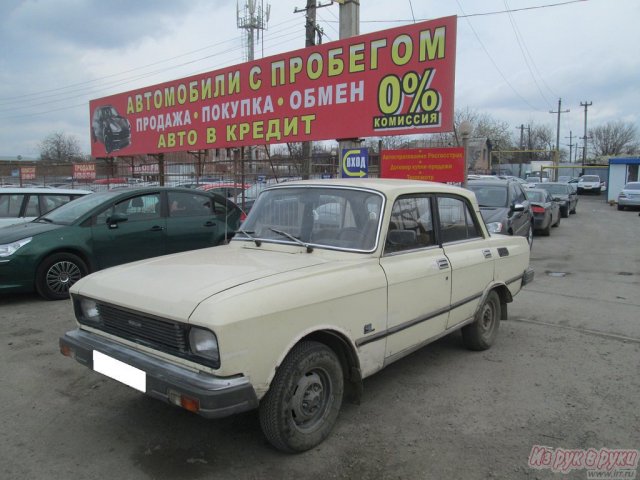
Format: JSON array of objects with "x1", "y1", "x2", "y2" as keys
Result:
[{"x1": 97, "y1": 304, "x2": 189, "y2": 356}]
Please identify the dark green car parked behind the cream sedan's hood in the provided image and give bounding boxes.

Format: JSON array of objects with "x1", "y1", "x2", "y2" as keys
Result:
[{"x1": 0, "y1": 187, "x2": 243, "y2": 300}]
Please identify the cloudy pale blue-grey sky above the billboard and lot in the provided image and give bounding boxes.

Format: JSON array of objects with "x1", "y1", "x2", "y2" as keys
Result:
[{"x1": 0, "y1": 0, "x2": 640, "y2": 157}]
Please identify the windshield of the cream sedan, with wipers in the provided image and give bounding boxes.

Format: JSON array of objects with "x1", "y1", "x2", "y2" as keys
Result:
[{"x1": 234, "y1": 186, "x2": 384, "y2": 251}]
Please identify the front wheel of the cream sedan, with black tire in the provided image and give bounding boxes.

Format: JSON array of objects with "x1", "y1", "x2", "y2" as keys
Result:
[{"x1": 259, "y1": 341, "x2": 344, "y2": 453}]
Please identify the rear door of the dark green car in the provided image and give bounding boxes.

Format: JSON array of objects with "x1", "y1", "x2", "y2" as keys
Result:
[{"x1": 166, "y1": 190, "x2": 230, "y2": 253}]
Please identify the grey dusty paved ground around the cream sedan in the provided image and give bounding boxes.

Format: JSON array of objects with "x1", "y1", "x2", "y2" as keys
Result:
[{"x1": 0, "y1": 196, "x2": 640, "y2": 480}]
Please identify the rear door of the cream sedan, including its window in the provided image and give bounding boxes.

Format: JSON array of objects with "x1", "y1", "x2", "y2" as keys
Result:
[{"x1": 437, "y1": 195, "x2": 494, "y2": 328}]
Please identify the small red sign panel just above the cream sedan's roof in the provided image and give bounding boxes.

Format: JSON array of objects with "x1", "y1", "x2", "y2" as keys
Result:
[{"x1": 380, "y1": 147, "x2": 464, "y2": 183}]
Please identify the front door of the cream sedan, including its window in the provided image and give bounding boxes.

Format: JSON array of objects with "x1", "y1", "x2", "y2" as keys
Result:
[{"x1": 380, "y1": 195, "x2": 451, "y2": 362}]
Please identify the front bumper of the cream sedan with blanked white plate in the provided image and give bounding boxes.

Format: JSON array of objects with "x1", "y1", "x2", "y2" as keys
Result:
[{"x1": 60, "y1": 329, "x2": 258, "y2": 418}]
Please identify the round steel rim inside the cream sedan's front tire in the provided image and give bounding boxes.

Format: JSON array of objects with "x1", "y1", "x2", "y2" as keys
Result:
[{"x1": 292, "y1": 370, "x2": 331, "y2": 430}]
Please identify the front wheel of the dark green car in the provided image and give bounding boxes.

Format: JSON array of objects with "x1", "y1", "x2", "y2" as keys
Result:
[{"x1": 36, "y1": 253, "x2": 89, "y2": 300}]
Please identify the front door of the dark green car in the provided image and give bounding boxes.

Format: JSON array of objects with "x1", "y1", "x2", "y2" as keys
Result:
[{"x1": 91, "y1": 192, "x2": 166, "y2": 268}]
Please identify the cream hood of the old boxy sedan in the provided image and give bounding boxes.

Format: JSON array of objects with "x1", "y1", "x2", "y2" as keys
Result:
[{"x1": 71, "y1": 244, "x2": 329, "y2": 321}]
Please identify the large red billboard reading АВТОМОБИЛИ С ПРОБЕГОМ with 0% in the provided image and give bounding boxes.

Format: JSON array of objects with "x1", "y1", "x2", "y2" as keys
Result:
[{"x1": 89, "y1": 17, "x2": 456, "y2": 157}]
